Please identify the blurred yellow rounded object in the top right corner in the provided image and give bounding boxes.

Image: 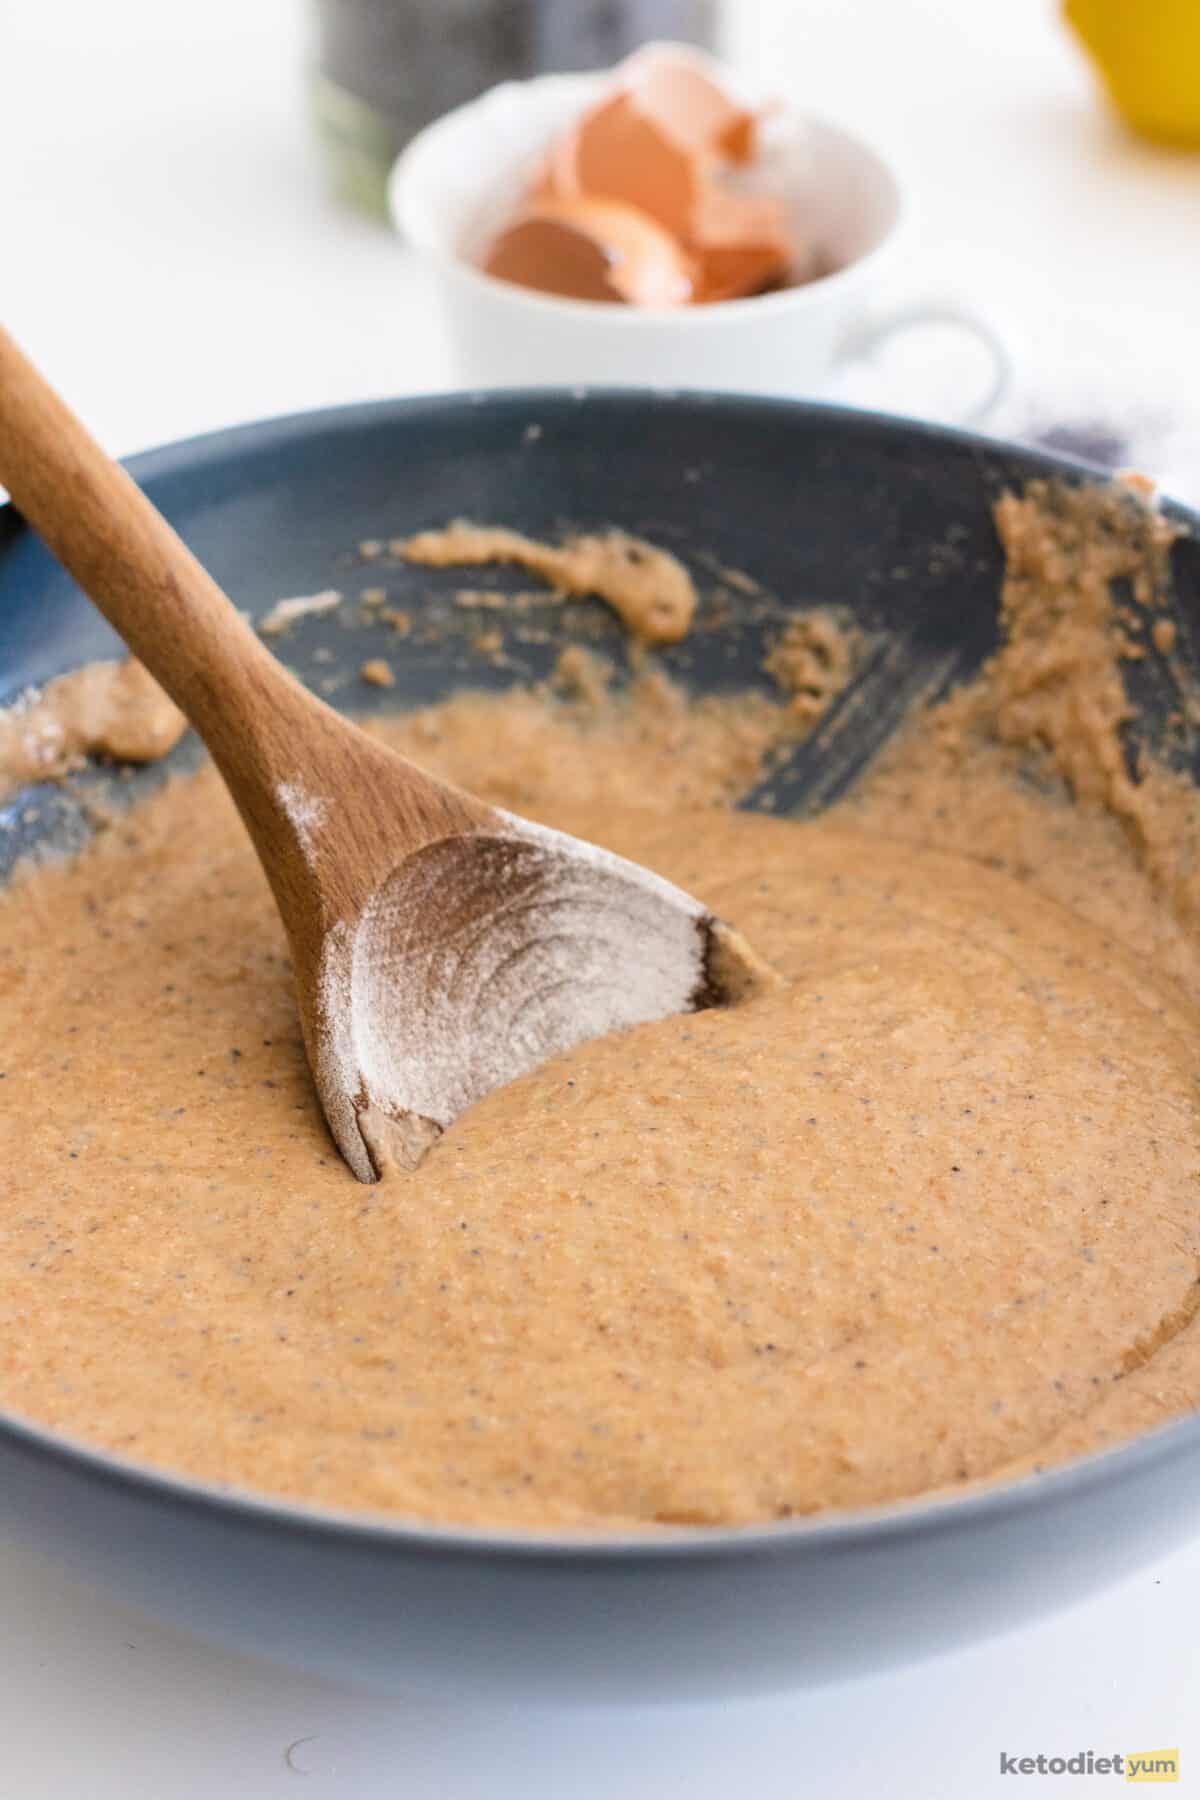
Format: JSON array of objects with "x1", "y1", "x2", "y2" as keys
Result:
[{"x1": 1063, "y1": 0, "x2": 1200, "y2": 149}]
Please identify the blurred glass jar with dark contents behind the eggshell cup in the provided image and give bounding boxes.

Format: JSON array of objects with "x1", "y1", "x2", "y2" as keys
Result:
[{"x1": 309, "y1": 0, "x2": 718, "y2": 218}]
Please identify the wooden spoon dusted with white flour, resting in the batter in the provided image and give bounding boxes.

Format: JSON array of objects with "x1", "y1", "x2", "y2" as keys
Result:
[{"x1": 0, "y1": 331, "x2": 759, "y2": 1181}]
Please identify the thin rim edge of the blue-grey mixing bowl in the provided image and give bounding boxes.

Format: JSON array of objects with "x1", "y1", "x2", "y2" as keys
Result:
[{"x1": 0, "y1": 387, "x2": 1200, "y2": 1568}]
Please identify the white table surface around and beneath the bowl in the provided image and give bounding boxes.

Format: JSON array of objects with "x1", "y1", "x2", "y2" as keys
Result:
[{"x1": 0, "y1": 0, "x2": 1200, "y2": 1800}]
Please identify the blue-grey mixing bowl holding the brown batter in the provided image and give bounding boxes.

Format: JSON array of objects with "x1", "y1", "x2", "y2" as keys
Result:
[{"x1": 0, "y1": 391, "x2": 1200, "y2": 1701}]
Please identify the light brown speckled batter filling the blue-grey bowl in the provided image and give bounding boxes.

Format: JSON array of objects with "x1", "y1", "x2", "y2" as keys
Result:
[{"x1": 0, "y1": 491, "x2": 1200, "y2": 1528}]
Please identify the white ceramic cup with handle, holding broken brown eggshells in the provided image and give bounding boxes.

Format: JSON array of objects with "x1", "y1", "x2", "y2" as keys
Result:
[{"x1": 390, "y1": 74, "x2": 1009, "y2": 423}]
